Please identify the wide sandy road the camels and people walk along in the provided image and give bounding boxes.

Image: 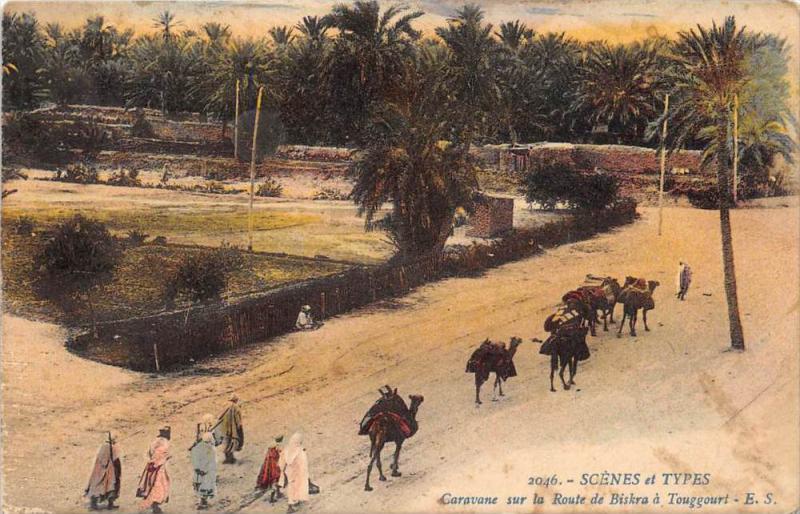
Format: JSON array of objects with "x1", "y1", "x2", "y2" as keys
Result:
[{"x1": 3, "y1": 201, "x2": 800, "y2": 512}]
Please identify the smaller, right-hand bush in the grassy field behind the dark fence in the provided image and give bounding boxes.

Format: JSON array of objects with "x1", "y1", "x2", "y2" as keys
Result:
[{"x1": 166, "y1": 252, "x2": 227, "y2": 302}]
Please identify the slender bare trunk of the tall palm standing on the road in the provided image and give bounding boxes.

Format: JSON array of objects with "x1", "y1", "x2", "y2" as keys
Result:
[{"x1": 717, "y1": 120, "x2": 744, "y2": 350}]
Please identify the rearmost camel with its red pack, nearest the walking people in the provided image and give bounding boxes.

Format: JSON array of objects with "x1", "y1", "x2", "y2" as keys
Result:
[{"x1": 362, "y1": 389, "x2": 425, "y2": 491}]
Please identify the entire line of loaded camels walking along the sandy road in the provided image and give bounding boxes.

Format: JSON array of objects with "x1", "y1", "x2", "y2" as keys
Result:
[{"x1": 358, "y1": 275, "x2": 659, "y2": 491}]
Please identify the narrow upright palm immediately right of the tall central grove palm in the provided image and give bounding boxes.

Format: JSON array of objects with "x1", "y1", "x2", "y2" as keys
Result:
[{"x1": 436, "y1": 5, "x2": 497, "y2": 156}]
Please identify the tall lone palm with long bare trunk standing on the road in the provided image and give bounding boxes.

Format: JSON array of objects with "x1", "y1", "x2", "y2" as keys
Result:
[{"x1": 659, "y1": 16, "x2": 765, "y2": 350}]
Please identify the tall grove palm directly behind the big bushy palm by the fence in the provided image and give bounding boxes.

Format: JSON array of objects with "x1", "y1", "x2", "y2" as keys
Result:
[{"x1": 325, "y1": 0, "x2": 422, "y2": 143}]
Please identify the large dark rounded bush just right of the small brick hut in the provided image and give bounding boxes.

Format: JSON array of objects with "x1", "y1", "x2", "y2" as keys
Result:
[{"x1": 524, "y1": 160, "x2": 619, "y2": 210}]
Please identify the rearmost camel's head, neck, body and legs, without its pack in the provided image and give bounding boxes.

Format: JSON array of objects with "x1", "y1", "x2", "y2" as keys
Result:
[{"x1": 364, "y1": 395, "x2": 425, "y2": 491}]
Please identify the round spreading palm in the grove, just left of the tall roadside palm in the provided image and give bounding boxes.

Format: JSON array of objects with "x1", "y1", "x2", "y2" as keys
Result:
[{"x1": 571, "y1": 42, "x2": 663, "y2": 142}]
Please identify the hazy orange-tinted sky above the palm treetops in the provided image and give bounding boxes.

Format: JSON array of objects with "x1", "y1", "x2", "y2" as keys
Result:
[{"x1": 5, "y1": 0, "x2": 800, "y2": 43}]
